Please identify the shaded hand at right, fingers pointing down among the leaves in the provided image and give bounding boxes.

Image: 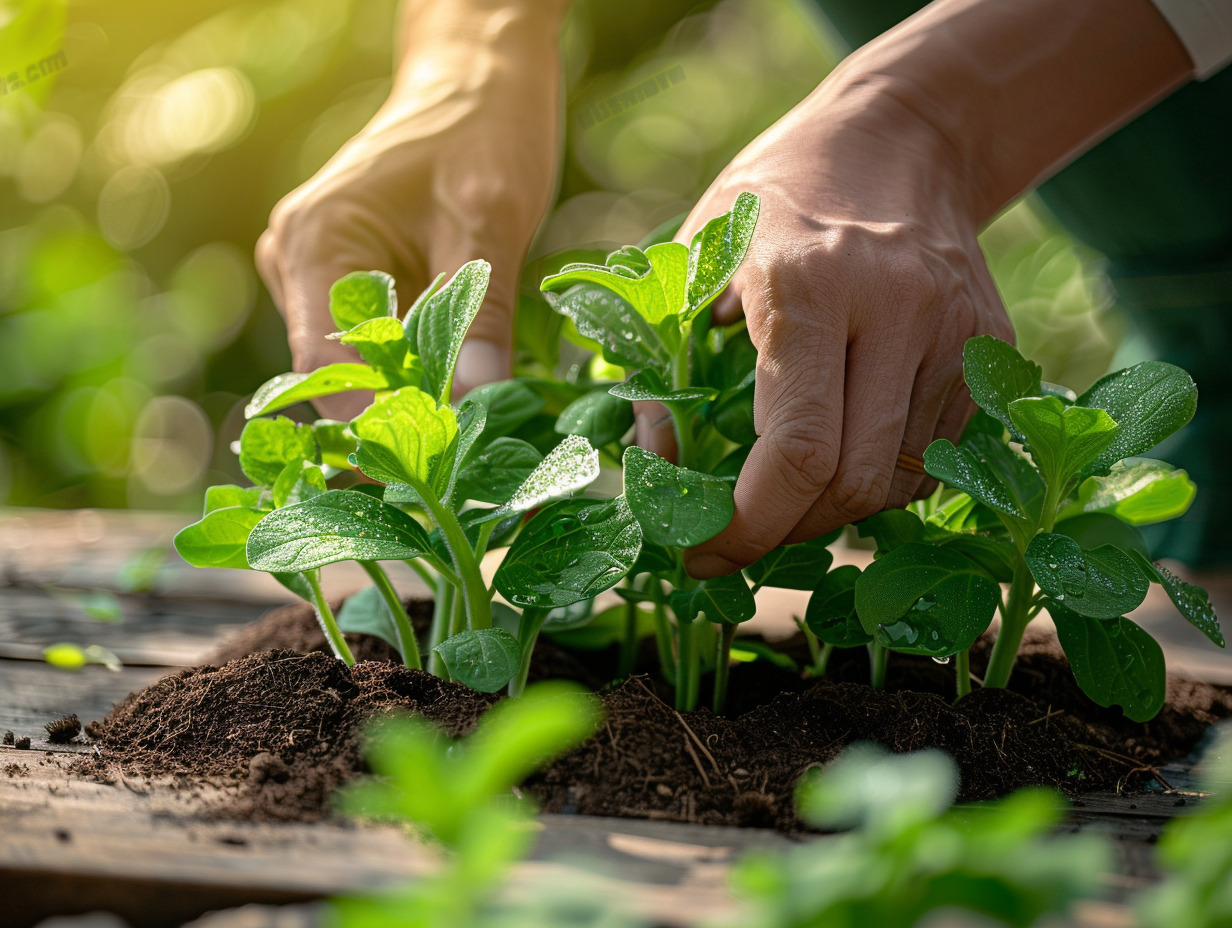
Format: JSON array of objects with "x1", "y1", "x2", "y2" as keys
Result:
[{"x1": 680, "y1": 79, "x2": 1013, "y2": 578}]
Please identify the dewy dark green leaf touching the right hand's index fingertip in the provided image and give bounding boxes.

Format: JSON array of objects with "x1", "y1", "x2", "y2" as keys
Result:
[{"x1": 623, "y1": 445, "x2": 734, "y2": 547}]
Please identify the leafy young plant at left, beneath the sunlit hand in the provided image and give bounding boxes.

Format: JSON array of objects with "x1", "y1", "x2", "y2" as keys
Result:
[{"x1": 176, "y1": 261, "x2": 641, "y2": 693}]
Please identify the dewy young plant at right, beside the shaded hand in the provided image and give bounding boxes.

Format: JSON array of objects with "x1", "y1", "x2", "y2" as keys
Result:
[{"x1": 855, "y1": 336, "x2": 1223, "y2": 721}]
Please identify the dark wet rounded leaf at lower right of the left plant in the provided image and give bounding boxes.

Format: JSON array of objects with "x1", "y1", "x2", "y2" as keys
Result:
[{"x1": 494, "y1": 497, "x2": 642, "y2": 609}]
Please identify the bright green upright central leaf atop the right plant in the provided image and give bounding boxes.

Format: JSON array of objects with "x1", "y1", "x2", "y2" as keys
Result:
[{"x1": 1009, "y1": 397, "x2": 1119, "y2": 488}]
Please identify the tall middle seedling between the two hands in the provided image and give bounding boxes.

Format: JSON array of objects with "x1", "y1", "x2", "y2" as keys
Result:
[{"x1": 542, "y1": 193, "x2": 833, "y2": 711}]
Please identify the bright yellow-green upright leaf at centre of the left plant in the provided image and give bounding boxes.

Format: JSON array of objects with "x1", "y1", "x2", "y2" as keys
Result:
[{"x1": 351, "y1": 387, "x2": 458, "y2": 494}]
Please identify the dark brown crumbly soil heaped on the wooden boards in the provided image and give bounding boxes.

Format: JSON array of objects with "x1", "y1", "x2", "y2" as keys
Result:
[{"x1": 84, "y1": 608, "x2": 1232, "y2": 829}]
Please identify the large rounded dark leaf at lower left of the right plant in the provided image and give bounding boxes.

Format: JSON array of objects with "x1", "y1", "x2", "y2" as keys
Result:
[{"x1": 855, "y1": 542, "x2": 1000, "y2": 657}]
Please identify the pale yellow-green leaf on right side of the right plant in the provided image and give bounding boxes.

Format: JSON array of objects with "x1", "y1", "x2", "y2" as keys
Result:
[{"x1": 1058, "y1": 457, "x2": 1198, "y2": 525}]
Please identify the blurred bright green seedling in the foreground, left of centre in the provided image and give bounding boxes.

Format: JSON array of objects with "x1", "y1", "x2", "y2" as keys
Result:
[{"x1": 331, "y1": 684, "x2": 628, "y2": 928}]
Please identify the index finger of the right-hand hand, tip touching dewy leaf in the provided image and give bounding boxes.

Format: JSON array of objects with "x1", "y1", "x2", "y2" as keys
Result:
[{"x1": 685, "y1": 297, "x2": 846, "y2": 578}]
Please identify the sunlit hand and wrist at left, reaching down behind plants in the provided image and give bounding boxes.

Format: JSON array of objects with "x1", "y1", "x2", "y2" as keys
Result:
[{"x1": 256, "y1": 0, "x2": 562, "y2": 419}]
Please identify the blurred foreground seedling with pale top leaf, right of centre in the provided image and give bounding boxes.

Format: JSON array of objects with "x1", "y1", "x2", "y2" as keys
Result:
[{"x1": 731, "y1": 746, "x2": 1110, "y2": 928}]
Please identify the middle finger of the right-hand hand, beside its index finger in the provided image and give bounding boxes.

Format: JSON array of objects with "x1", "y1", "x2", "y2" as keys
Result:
[{"x1": 782, "y1": 327, "x2": 935, "y2": 545}]
